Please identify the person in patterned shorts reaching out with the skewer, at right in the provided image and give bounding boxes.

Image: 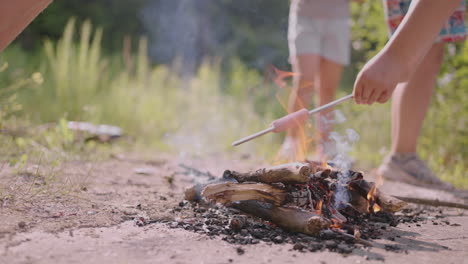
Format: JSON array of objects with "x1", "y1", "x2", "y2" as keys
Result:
[{"x1": 353, "y1": 0, "x2": 466, "y2": 188}]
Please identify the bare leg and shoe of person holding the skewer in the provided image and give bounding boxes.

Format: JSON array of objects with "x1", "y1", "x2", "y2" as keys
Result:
[{"x1": 378, "y1": 43, "x2": 453, "y2": 190}]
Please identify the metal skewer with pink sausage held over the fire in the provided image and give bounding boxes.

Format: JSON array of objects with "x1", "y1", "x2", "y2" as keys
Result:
[{"x1": 232, "y1": 94, "x2": 353, "y2": 146}]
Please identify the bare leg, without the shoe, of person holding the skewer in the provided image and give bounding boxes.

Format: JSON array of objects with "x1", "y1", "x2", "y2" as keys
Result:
[{"x1": 392, "y1": 43, "x2": 444, "y2": 153}]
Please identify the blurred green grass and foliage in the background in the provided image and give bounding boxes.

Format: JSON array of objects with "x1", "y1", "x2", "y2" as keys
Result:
[{"x1": 0, "y1": 0, "x2": 468, "y2": 188}]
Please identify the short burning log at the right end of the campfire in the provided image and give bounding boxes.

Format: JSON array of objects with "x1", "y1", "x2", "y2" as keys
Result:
[{"x1": 349, "y1": 180, "x2": 407, "y2": 213}]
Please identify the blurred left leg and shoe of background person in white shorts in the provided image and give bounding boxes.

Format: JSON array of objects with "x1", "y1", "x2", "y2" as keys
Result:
[{"x1": 280, "y1": 54, "x2": 320, "y2": 160}]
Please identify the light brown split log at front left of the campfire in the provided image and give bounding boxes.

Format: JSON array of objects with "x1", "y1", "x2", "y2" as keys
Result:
[{"x1": 202, "y1": 182, "x2": 288, "y2": 205}]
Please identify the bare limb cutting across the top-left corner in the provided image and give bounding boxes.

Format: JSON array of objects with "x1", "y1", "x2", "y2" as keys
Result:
[{"x1": 0, "y1": 0, "x2": 52, "y2": 52}]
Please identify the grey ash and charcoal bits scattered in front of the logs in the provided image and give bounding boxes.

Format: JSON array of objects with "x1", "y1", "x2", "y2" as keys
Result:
[{"x1": 154, "y1": 203, "x2": 410, "y2": 254}]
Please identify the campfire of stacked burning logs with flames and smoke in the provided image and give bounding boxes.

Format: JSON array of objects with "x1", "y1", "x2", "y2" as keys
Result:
[{"x1": 185, "y1": 162, "x2": 406, "y2": 242}]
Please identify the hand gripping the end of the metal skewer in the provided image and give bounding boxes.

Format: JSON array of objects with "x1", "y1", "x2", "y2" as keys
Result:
[{"x1": 353, "y1": 52, "x2": 407, "y2": 105}]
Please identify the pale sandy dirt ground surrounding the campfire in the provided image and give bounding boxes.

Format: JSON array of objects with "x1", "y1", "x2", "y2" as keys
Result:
[{"x1": 0, "y1": 155, "x2": 468, "y2": 264}]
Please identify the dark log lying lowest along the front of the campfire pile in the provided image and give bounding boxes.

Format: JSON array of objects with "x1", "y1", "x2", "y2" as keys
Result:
[{"x1": 233, "y1": 201, "x2": 331, "y2": 235}]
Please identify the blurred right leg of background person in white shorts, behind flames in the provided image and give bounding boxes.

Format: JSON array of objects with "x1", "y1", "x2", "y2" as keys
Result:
[{"x1": 315, "y1": 58, "x2": 343, "y2": 156}]
